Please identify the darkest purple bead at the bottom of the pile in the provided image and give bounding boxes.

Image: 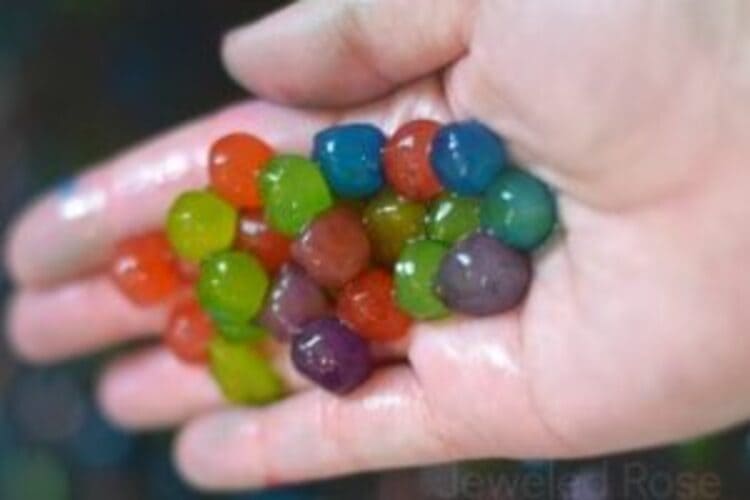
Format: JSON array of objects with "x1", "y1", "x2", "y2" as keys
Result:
[{"x1": 292, "y1": 318, "x2": 373, "y2": 394}]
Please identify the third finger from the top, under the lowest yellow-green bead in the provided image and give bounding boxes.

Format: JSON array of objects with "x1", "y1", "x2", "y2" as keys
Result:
[{"x1": 98, "y1": 347, "x2": 309, "y2": 430}]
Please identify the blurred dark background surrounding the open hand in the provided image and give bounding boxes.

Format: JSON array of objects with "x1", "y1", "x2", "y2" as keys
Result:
[{"x1": 0, "y1": 0, "x2": 750, "y2": 500}]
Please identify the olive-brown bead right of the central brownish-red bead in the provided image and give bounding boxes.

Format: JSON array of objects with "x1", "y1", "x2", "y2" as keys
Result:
[{"x1": 364, "y1": 190, "x2": 426, "y2": 265}]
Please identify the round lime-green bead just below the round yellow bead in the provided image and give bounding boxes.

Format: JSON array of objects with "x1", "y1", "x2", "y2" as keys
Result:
[{"x1": 198, "y1": 251, "x2": 268, "y2": 323}]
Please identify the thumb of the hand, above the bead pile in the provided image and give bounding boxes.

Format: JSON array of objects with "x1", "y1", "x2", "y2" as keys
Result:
[{"x1": 223, "y1": 0, "x2": 476, "y2": 106}]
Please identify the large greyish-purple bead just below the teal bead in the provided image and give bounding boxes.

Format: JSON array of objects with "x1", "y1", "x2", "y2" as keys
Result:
[{"x1": 437, "y1": 233, "x2": 531, "y2": 316}]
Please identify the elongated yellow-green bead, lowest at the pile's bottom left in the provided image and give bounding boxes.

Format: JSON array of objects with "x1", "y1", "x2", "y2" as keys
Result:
[{"x1": 209, "y1": 335, "x2": 284, "y2": 405}]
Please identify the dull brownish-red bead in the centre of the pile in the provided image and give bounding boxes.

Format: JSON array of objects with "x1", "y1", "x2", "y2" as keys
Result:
[{"x1": 292, "y1": 207, "x2": 370, "y2": 288}]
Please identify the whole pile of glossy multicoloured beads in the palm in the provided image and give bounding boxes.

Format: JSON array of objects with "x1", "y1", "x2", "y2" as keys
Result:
[{"x1": 112, "y1": 120, "x2": 556, "y2": 404}]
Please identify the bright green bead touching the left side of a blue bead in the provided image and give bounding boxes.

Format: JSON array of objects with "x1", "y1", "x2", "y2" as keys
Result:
[{"x1": 260, "y1": 155, "x2": 333, "y2": 236}]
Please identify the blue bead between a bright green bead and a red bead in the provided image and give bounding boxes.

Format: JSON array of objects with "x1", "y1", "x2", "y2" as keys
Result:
[{"x1": 313, "y1": 123, "x2": 386, "y2": 198}]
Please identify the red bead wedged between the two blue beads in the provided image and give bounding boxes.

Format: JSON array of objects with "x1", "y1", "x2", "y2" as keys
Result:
[{"x1": 383, "y1": 120, "x2": 443, "y2": 201}]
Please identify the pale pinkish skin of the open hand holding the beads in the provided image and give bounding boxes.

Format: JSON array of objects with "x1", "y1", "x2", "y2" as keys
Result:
[{"x1": 7, "y1": 0, "x2": 750, "y2": 489}]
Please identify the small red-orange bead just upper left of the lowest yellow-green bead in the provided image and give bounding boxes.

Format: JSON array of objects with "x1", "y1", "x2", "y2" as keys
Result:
[{"x1": 164, "y1": 299, "x2": 215, "y2": 363}]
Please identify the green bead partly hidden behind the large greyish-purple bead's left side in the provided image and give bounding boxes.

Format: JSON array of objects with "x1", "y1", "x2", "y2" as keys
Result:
[{"x1": 395, "y1": 240, "x2": 448, "y2": 320}]
